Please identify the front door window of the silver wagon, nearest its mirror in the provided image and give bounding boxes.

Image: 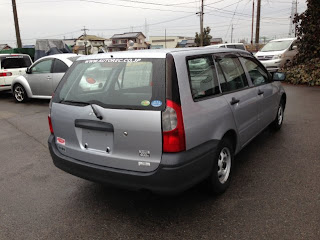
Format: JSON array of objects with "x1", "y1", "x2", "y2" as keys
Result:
[{"x1": 243, "y1": 58, "x2": 269, "y2": 86}]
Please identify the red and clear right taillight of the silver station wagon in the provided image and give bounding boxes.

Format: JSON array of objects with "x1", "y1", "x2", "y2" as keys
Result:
[{"x1": 162, "y1": 100, "x2": 186, "y2": 152}]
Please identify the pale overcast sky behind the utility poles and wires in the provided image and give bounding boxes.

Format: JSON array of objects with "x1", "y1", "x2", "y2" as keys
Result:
[{"x1": 0, "y1": 0, "x2": 306, "y2": 47}]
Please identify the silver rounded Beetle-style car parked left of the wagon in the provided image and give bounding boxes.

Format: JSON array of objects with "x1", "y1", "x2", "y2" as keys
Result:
[{"x1": 11, "y1": 53, "x2": 79, "y2": 103}]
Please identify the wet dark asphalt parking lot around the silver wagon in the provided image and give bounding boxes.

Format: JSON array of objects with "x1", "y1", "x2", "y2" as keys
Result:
[{"x1": 0, "y1": 85, "x2": 320, "y2": 240}]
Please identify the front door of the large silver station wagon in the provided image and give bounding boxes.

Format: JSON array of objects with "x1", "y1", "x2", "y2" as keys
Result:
[{"x1": 241, "y1": 57, "x2": 277, "y2": 130}]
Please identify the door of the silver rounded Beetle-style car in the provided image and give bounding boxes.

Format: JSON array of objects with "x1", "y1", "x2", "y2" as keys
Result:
[{"x1": 26, "y1": 58, "x2": 53, "y2": 96}]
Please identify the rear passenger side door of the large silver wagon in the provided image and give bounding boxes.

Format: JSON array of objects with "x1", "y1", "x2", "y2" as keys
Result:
[{"x1": 215, "y1": 54, "x2": 259, "y2": 146}]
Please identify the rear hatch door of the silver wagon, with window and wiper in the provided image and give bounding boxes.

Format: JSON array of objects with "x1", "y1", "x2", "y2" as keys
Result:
[{"x1": 51, "y1": 59, "x2": 165, "y2": 172}]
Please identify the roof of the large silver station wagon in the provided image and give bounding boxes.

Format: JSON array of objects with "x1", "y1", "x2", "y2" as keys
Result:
[{"x1": 76, "y1": 47, "x2": 248, "y2": 61}]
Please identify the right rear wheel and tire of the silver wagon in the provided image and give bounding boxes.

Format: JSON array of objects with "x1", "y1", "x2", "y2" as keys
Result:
[{"x1": 207, "y1": 138, "x2": 234, "y2": 195}]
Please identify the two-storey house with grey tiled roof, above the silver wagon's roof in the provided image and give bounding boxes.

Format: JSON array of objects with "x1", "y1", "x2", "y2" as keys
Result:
[{"x1": 108, "y1": 32, "x2": 148, "y2": 52}]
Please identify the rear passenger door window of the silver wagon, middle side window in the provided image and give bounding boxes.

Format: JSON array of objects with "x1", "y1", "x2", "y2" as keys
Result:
[{"x1": 217, "y1": 57, "x2": 249, "y2": 92}]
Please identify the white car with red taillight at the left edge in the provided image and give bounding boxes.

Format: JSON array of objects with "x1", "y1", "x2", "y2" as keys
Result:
[{"x1": 0, "y1": 53, "x2": 32, "y2": 91}]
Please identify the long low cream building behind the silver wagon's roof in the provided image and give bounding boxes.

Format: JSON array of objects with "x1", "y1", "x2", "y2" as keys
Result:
[{"x1": 148, "y1": 36, "x2": 194, "y2": 48}]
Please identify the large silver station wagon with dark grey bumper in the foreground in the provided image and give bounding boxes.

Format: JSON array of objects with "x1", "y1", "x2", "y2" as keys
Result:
[{"x1": 48, "y1": 48, "x2": 286, "y2": 193}]
